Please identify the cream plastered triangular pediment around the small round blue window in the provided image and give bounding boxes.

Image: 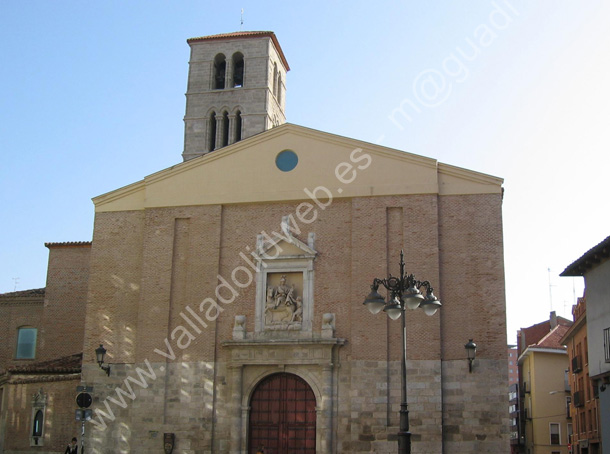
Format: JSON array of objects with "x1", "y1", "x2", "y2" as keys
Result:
[{"x1": 93, "y1": 124, "x2": 502, "y2": 212}]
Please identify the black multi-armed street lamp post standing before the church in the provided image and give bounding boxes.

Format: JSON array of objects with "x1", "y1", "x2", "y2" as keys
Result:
[{"x1": 364, "y1": 251, "x2": 441, "y2": 454}]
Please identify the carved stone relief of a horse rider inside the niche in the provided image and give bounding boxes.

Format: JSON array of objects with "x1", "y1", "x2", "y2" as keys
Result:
[{"x1": 265, "y1": 275, "x2": 303, "y2": 329}]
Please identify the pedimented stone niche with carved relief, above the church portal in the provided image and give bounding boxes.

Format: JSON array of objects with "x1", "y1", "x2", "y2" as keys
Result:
[{"x1": 254, "y1": 218, "x2": 317, "y2": 337}]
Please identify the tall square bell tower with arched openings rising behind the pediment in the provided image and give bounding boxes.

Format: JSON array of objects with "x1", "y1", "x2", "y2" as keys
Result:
[{"x1": 182, "y1": 31, "x2": 290, "y2": 161}]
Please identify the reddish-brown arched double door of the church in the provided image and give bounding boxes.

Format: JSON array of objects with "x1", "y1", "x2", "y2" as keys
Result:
[{"x1": 248, "y1": 373, "x2": 316, "y2": 454}]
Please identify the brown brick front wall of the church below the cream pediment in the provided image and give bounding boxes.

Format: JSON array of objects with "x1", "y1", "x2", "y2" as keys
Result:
[{"x1": 85, "y1": 190, "x2": 508, "y2": 453}]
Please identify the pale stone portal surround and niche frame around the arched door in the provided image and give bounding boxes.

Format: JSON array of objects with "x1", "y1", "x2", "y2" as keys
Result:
[{"x1": 222, "y1": 225, "x2": 345, "y2": 454}]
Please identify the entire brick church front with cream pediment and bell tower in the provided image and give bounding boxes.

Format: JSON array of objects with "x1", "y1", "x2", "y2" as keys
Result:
[{"x1": 83, "y1": 32, "x2": 508, "y2": 454}]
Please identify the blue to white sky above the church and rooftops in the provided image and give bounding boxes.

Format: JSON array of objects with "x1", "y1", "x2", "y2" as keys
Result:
[{"x1": 0, "y1": 0, "x2": 610, "y2": 341}]
